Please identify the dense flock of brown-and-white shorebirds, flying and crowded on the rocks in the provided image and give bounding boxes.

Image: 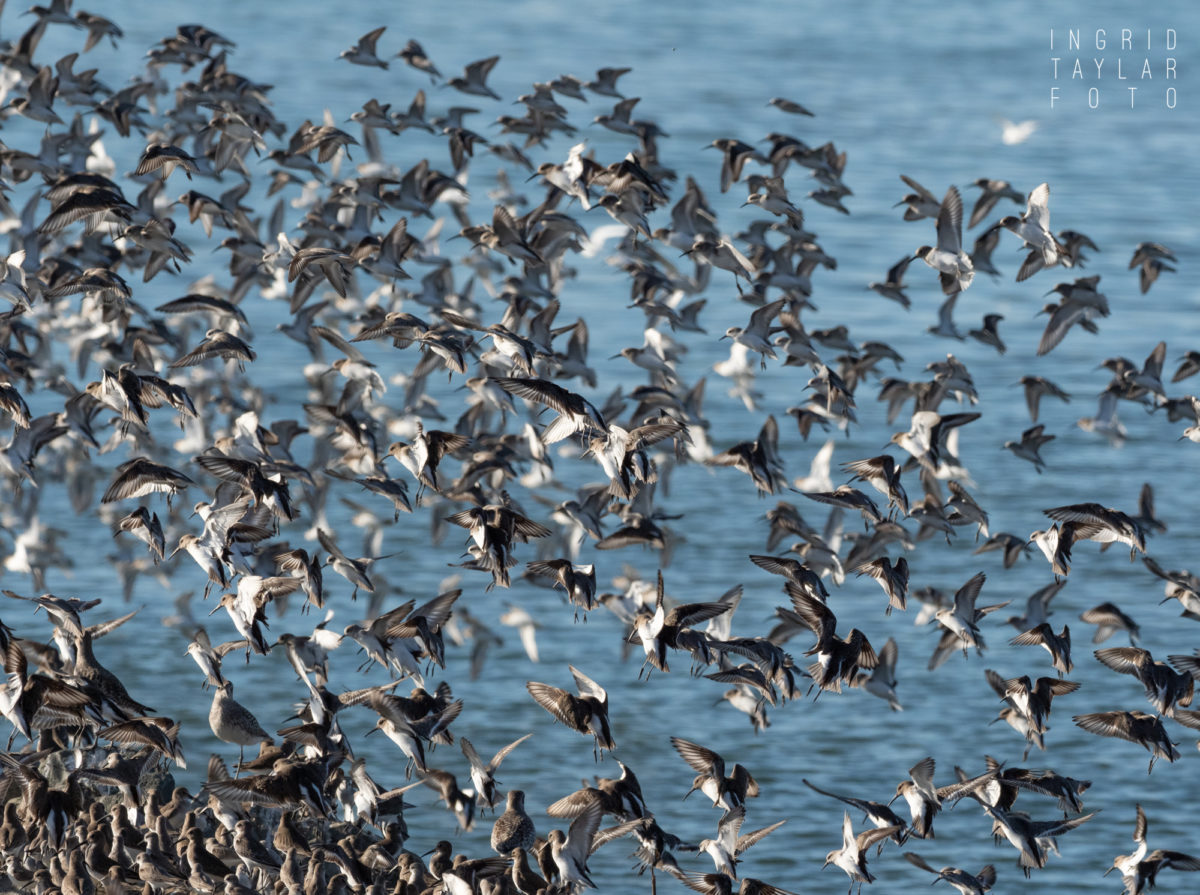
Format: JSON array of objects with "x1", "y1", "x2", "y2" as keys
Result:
[{"x1": 0, "y1": 0, "x2": 1200, "y2": 895}]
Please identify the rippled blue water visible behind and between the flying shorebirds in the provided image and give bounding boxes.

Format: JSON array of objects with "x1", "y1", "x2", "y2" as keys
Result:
[{"x1": 0, "y1": 0, "x2": 1200, "y2": 893}]
